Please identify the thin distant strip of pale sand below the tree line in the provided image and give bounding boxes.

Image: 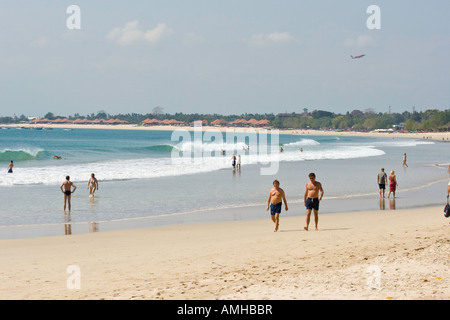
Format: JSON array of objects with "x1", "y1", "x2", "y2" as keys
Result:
[{"x1": 2, "y1": 124, "x2": 450, "y2": 142}]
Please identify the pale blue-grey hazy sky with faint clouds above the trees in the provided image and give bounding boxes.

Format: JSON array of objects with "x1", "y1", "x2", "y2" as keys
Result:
[{"x1": 0, "y1": 0, "x2": 450, "y2": 117}]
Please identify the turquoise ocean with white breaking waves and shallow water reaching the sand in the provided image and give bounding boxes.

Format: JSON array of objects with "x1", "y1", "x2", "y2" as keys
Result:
[{"x1": 0, "y1": 127, "x2": 449, "y2": 238}]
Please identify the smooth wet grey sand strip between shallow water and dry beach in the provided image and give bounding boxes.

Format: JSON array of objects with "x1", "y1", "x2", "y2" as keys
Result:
[{"x1": 0, "y1": 175, "x2": 447, "y2": 241}]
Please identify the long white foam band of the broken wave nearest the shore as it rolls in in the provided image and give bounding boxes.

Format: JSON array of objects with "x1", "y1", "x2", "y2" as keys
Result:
[{"x1": 0, "y1": 146, "x2": 385, "y2": 186}]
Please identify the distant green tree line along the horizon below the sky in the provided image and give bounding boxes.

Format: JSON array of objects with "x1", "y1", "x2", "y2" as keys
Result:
[{"x1": 0, "y1": 107, "x2": 450, "y2": 131}]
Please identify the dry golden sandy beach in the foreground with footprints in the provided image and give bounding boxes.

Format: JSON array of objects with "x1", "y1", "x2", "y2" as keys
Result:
[{"x1": 0, "y1": 207, "x2": 450, "y2": 300}]
